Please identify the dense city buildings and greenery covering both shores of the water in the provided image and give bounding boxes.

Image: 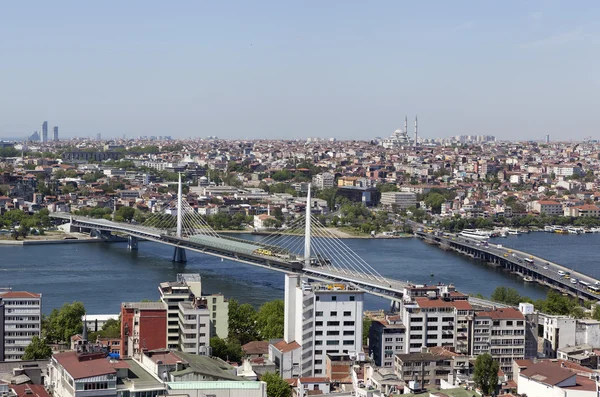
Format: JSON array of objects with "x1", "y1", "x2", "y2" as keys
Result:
[{"x1": 0, "y1": 124, "x2": 600, "y2": 396}]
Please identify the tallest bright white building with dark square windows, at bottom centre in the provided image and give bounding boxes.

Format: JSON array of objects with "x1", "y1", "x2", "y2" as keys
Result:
[{"x1": 269, "y1": 274, "x2": 364, "y2": 377}]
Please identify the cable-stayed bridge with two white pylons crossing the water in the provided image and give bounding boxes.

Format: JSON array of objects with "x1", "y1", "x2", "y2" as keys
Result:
[{"x1": 51, "y1": 182, "x2": 501, "y2": 306}]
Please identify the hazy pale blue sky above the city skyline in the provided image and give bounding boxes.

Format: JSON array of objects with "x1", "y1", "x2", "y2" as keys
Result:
[{"x1": 0, "y1": 0, "x2": 600, "y2": 140}]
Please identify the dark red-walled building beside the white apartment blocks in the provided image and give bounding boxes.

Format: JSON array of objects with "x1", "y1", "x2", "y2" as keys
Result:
[{"x1": 120, "y1": 302, "x2": 168, "y2": 358}]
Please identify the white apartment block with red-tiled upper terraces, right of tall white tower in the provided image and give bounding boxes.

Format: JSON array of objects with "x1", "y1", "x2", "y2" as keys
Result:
[{"x1": 400, "y1": 285, "x2": 473, "y2": 354}]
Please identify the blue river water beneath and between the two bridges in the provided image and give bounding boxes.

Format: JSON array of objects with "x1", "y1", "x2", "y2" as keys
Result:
[{"x1": 0, "y1": 233, "x2": 600, "y2": 314}]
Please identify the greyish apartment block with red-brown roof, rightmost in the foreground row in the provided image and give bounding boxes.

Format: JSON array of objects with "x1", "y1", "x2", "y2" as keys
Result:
[{"x1": 470, "y1": 308, "x2": 526, "y2": 379}]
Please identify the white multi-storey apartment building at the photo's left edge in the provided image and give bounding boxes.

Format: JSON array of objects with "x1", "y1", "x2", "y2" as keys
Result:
[{"x1": 0, "y1": 289, "x2": 42, "y2": 361}]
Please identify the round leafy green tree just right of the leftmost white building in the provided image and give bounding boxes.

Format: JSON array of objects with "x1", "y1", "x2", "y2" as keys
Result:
[{"x1": 42, "y1": 302, "x2": 85, "y2": 342}]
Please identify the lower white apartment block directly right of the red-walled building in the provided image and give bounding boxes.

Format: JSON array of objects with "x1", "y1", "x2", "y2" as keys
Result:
[{"x1": 179, "y1": 299, "x2": 212, "y2": 356}]
